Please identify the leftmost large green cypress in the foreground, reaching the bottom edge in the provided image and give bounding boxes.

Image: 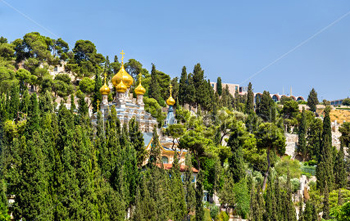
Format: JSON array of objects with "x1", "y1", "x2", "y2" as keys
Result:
[{"x1": 13, "y1": 134, "x2": 53, "y2": 220}]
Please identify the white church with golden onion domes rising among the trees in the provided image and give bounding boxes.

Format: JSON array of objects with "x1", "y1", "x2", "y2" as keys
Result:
[{"x1": 92, "y1": 51, "x2": 186, "y2": 167}]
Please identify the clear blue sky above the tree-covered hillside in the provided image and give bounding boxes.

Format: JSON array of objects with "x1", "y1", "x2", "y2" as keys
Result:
[{"x1": 0, "y1": 0, "x2": 350, "y2": 100}]
